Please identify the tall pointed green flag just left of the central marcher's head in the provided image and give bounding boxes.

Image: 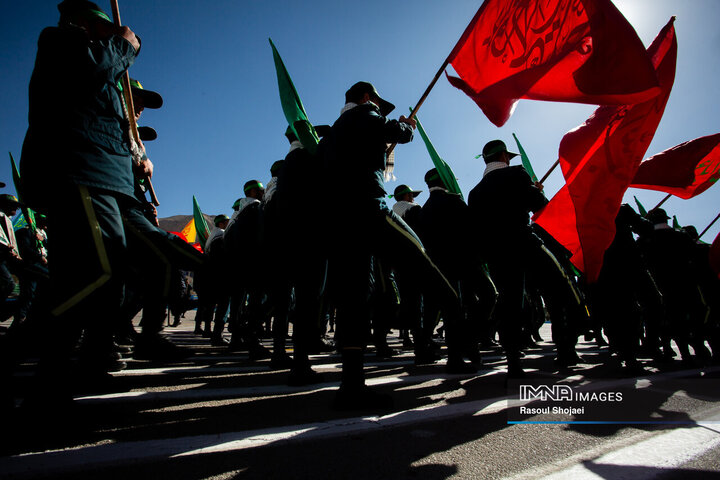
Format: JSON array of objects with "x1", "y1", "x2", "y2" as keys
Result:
[{"x1": 268, "y1": 38, "x2": 320, "y2": 154}]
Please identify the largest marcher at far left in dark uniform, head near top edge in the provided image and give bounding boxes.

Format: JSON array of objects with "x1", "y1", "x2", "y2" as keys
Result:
[{"x1": 20, "y1": 0, "x2": 145, "y2": 395}]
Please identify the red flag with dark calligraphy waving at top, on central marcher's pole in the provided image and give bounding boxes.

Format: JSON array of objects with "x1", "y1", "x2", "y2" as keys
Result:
[{"x1": 448, "y1": 0, "x2": 660, "y2": 127}]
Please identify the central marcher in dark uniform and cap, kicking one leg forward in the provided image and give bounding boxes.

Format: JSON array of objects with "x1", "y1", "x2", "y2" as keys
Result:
[{"x1": 320, "y1": 82, "x2": 456, "y2": 409}]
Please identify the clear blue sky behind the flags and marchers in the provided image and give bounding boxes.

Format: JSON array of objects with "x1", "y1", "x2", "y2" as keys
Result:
[{"x1": 0, "y1": 0, "x2": 720, "y2": 241}]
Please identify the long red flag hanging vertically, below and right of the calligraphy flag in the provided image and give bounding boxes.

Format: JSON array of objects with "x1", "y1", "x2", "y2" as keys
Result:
[{"x1": 534, "y1": 18, "x2": 677, "y2": 282}]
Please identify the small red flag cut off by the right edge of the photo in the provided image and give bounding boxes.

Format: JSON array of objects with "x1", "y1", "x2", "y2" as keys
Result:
[{"x1": 630, "y1": 133, "x2": 720, "y2": 200}]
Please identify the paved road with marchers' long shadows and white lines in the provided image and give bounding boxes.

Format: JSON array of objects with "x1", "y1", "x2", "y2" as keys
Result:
[{"x1": 0, "y1": 319, "x2": 720, "y2": 480}]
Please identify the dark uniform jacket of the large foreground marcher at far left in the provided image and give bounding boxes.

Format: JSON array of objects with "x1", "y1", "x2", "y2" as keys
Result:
[{"x1": 20, "y1": 26, "x2": 136, "y2": 206}]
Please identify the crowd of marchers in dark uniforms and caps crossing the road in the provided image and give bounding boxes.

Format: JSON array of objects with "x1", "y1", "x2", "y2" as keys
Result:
[{"x1": 0, "y1": 0, "x2": 720, "y2": 409}]
